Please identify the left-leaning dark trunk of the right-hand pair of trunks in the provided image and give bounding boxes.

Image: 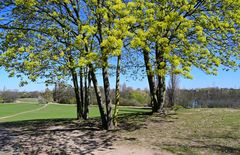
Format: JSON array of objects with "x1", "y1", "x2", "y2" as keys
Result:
[{"x1": 143, "y1": 51, "x2": 160, "y2": 113}]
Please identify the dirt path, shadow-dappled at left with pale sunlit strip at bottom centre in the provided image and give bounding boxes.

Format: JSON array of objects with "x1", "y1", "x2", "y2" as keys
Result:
[{"x1": 0, "y1": 125, "x2": 172, "y2": 155}]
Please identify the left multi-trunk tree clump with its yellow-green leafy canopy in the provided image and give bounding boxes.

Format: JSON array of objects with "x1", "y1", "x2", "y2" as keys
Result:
[{"x1": 0, "y1": 0, "x2": 134, "y2": 129}]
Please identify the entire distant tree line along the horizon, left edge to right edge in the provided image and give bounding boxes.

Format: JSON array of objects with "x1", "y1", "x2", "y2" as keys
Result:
[{"x1": 0, "y1": 84, "x2": 240, "y2": 108}]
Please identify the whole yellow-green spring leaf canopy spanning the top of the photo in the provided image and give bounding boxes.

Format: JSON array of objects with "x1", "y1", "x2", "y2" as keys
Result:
[{"x1": 0, "y1": 0, "x2": 240, "y2": 80}]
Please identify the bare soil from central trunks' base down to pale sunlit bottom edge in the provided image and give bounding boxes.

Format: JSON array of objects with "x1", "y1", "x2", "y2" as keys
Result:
[{"x1": 0, "y1": 115, "x2": 169, "y2": 155}]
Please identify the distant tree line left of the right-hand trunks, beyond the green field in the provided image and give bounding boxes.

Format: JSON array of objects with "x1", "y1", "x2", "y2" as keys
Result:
[{"x1": 0, "y1": 82, "x2": 151, "y2": 106}]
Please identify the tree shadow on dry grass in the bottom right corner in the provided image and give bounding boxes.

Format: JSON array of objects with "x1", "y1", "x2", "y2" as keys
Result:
[{"x1": 160, "y1": 132, "x2": 240, "y2": 155}]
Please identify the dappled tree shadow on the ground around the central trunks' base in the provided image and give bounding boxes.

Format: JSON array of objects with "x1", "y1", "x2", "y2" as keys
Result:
[{"x1": 0, "y1": 113, "x2": 152, "y2": 154}]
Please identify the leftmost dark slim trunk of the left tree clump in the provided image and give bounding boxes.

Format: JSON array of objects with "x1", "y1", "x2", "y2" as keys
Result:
[{"x1": 71, "y1": 69, "x2": 82, "y2": 119}]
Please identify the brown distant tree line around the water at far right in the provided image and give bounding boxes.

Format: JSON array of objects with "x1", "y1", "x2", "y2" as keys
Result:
[{"x1": 176, "y1": 88, "x2": 240, "y2": 108}]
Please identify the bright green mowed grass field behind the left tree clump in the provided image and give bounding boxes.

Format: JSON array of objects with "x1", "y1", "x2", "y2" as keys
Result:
[{"x1": 0, "y1": 103, "x2": 150, "y2": 122}]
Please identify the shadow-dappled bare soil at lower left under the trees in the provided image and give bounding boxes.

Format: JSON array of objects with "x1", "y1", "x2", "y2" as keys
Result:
[{"x1": 0, "y1": 121, "x2": 118, "y2": 154}]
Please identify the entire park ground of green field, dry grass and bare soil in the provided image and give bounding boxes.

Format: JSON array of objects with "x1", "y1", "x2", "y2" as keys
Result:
[{"x1": 0, "y1": 100, "x2": 240, "y2": 155}]
